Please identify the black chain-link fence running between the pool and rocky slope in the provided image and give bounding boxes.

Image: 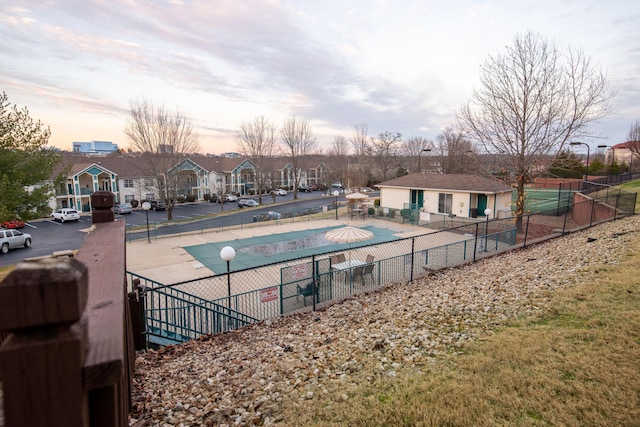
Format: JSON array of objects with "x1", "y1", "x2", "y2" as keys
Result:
[{"x1": 128, "y1": 192, "x2": 636, "y2": 345}]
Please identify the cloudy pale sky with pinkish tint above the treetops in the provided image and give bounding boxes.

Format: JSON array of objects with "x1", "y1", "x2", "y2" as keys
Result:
[{"x1": 0, "y1": 0, "x2": 640, "y2": 154}]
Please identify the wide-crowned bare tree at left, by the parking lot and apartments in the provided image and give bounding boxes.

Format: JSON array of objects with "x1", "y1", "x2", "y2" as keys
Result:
[{"x1": 124, "y1": 99, "x2": 199, "y2": 220}]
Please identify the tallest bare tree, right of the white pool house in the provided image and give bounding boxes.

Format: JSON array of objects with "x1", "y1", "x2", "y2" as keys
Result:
[{"x1": 459, "y1": 32, "x2": 613, "y2": 230}]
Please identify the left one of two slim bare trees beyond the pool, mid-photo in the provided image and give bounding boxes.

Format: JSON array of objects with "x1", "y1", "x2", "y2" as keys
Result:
[{"x1": 237, "y1": 116, "x2": 277, "y2": 204}]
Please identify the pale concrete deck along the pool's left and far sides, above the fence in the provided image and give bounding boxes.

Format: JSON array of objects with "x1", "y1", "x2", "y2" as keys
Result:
[{"x1": 126, "y1": 219, "x2": 429, "y2": 283}]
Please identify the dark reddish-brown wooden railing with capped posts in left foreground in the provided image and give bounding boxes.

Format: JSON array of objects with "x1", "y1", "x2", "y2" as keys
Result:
[{"x1": 0, "y1": 193, "x2": 134, "y2": 427}]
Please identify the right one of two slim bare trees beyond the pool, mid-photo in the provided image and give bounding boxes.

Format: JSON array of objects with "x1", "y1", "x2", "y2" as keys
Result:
[{"x1": 280, "y1": 116, "x2": 316, "y2": 199}]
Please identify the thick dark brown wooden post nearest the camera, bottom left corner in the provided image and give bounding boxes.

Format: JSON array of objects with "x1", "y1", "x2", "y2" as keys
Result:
[{"x1": 0, "y1": 258, "x2": 89, "y2": 427}]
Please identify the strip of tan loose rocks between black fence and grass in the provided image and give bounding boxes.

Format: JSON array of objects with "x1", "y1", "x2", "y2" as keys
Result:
[{"x1": 130, "y1": 216, "x2": 640, "y2": 426}]
